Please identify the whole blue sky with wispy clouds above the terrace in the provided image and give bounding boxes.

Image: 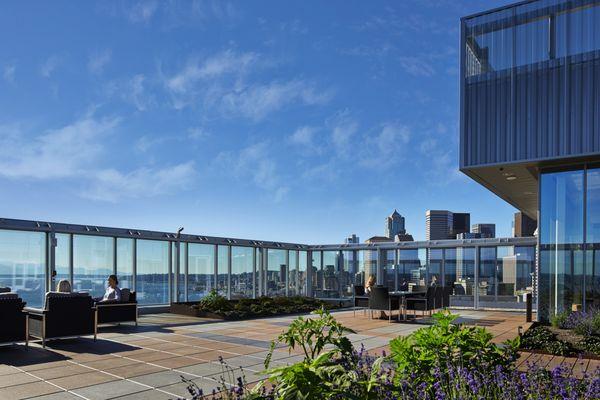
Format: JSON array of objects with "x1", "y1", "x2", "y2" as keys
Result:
[{"x1": 0, "y1": 1, "x2": 514, "y2": 244}]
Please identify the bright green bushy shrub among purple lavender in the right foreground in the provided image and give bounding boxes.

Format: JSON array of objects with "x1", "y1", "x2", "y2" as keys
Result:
[{"x1": 390, "y1": 312, "x2": 519, "y2": 382}]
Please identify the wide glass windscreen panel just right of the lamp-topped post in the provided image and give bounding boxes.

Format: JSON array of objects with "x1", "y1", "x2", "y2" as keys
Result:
[{"x1": 187, "y1": 243, "x2": 215, "y2": 301}]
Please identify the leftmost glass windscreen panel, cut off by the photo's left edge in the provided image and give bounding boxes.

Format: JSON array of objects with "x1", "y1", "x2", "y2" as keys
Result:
[{"x1": 0, "y1": 230, "x2": 46, "y2": 308}]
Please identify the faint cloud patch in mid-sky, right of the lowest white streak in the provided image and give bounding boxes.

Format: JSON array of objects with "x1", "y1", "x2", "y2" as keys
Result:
[{"x1": 215, "y1": 141, "x2": 289, "y2": 202}]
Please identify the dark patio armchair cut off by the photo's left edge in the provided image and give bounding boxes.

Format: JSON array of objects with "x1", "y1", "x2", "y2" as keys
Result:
[{"x1": 0, "y1": 288, "x2": 29, "y2": 346}]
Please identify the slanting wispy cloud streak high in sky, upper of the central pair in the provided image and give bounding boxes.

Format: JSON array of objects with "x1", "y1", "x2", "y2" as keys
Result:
[{"x1": 166, "y1": 50, "x2": 259, "y2": 93}]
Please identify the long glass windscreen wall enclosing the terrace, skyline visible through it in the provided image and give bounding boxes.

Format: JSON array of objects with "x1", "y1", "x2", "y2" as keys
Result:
[{"x1": 0, "y1": 219, "x2": 536, "y2": 309}]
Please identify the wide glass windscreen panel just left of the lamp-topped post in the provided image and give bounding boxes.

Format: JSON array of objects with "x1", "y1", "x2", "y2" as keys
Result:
[{"x1": 136, "y1": 240, "x2": 169, "y2": 304}]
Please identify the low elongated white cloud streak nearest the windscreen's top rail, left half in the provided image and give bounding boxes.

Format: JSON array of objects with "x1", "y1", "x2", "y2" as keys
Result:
[{"x1": 83, "y1": 161, "x2": 196, "y2": 202}]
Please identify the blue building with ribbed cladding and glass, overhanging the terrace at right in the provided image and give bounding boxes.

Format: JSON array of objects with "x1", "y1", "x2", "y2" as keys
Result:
[{"x1": 460, "y1": 0, "x2": 600, "y2": 320}]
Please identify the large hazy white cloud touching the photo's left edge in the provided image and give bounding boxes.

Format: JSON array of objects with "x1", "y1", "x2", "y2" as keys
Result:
[{"x1": 0, "y1": 116, "x2": 119, "y2": 179}]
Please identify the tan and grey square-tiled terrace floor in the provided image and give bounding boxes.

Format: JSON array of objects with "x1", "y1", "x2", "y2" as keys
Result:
[{"x1": 0, "y1": 310, "x2": 536, "y2": 400}]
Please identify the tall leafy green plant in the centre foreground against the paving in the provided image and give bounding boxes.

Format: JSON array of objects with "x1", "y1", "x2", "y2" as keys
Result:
[{"x1": 265, "y1": 307, "x2": 355, "y2": 368}]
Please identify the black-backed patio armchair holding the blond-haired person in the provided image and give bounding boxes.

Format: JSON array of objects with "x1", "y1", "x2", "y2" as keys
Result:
[{"x1": 25, "y1": 292, "x2": 96, "y2": 348}]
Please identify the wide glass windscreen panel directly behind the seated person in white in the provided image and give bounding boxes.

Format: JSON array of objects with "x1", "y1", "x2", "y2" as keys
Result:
[{"x1": 73, "y1": 235, "x2": 114, "y2": 297}]
